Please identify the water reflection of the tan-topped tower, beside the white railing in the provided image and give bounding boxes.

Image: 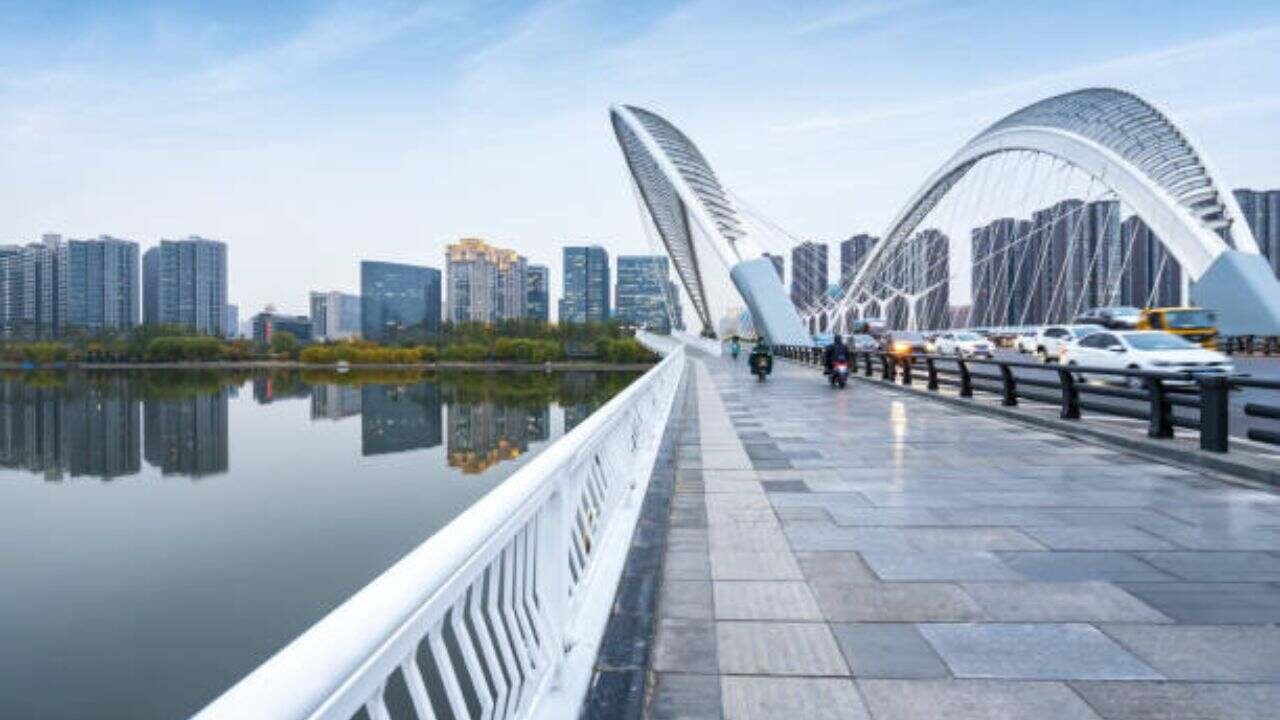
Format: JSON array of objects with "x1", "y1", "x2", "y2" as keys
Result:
[{"x1": 448, "y1": 402, "x2": 550, "y2": 475}]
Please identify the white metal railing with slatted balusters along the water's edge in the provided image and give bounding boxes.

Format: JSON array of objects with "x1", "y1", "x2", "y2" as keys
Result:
[{"x1": 196, "y1": 347, "x2": 685, "y2": 720}]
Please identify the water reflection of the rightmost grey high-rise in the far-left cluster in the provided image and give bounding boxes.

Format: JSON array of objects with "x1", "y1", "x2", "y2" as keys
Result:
[{"x1": 143, "y1": 388, "x2": 229, "y2": 478}]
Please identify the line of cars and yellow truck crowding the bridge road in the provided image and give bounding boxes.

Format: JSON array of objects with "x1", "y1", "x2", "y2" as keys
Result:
[{"x1": 814, "y1": 301, "x2": 1234, "y2": 382}]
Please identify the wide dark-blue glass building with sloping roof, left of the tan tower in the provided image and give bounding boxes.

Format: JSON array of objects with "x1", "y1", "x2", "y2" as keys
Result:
[{"x1": 360, "y1": 260, "x2": 440, "y2": 342}]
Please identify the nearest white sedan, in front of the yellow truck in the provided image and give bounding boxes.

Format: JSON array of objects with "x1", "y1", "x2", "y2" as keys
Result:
[{"x1": 1062, "y1": 331, "x2": 1235, "y2": 386}]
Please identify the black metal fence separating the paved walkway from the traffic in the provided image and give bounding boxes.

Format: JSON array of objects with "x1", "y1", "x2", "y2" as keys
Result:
[{"x1": 773, "y1": 345, "x2": 1280, "y2": 452}]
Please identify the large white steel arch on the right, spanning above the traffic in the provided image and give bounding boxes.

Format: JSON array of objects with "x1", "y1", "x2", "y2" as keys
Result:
[{"x1": 838, "y1": 88, "x2": 1280, "y2": 323}]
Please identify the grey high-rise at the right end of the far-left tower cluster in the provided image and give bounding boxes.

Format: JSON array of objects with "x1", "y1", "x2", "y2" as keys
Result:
[{"x1": 142, "y1": 236, "x2": 227, "y2": 336}]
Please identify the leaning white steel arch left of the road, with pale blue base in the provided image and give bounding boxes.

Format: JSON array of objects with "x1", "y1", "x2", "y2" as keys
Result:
[{"x1": 609, "y1": 105, "x2": 810, "y2": 345}]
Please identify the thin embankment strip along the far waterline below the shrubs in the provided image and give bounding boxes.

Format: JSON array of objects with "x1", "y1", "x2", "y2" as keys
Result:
[{"x1": 0, "y1": 360, "x2": 654, "y2": 373}]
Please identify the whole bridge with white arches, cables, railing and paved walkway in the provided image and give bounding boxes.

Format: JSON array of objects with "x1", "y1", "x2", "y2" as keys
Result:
[{"x1": 189, "y1": 90, "x2": 1280, "y2": 720}]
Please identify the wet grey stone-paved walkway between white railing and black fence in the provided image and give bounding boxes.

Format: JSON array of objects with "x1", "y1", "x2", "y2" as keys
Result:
[{"x1": 648, "y1": 354, "x2": 1280, "y2": 720}]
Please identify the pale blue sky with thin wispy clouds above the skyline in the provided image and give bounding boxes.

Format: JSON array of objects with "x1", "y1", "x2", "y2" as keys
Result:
[{"x1": 0, "y1": 0, "x2": 1280, "y2": 316}]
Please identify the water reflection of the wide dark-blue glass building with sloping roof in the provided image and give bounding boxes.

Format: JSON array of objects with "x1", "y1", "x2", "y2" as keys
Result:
[{"x1": 358, "y1": 383, "x2": 442, "y2": 456}]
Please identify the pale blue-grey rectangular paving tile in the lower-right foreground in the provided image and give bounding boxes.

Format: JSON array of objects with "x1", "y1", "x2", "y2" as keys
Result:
[{"x1": 920, "y1": 623, "x2": 1162, "y2": 680}]
